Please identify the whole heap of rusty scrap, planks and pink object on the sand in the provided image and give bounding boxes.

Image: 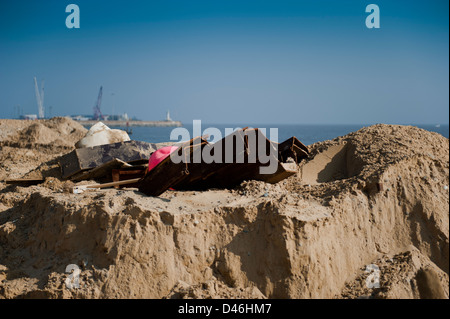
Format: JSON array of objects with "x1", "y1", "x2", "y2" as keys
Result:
[{"x1": 59, "y1": 122, "x2": 309, "y2": 196}]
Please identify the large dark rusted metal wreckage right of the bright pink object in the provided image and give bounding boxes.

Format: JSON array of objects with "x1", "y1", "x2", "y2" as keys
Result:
[{"x1": 139, "y1": 128, "x2": 309, "y2": 196}]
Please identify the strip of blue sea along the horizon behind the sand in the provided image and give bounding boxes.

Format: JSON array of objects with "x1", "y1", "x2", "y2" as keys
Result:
[{"x1": 104, "y1": 123, "x2": 449, "y2": 145}]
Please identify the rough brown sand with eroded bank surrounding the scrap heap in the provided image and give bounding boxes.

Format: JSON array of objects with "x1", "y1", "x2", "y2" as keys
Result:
[{"x1": 0, "y1": 118, "x2": 449, "y2": 299}]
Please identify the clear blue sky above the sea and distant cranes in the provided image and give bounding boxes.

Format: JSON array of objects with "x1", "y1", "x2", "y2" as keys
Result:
[{"x1": 0, "y1": 0, "x2": 449, "y2": 124}]
